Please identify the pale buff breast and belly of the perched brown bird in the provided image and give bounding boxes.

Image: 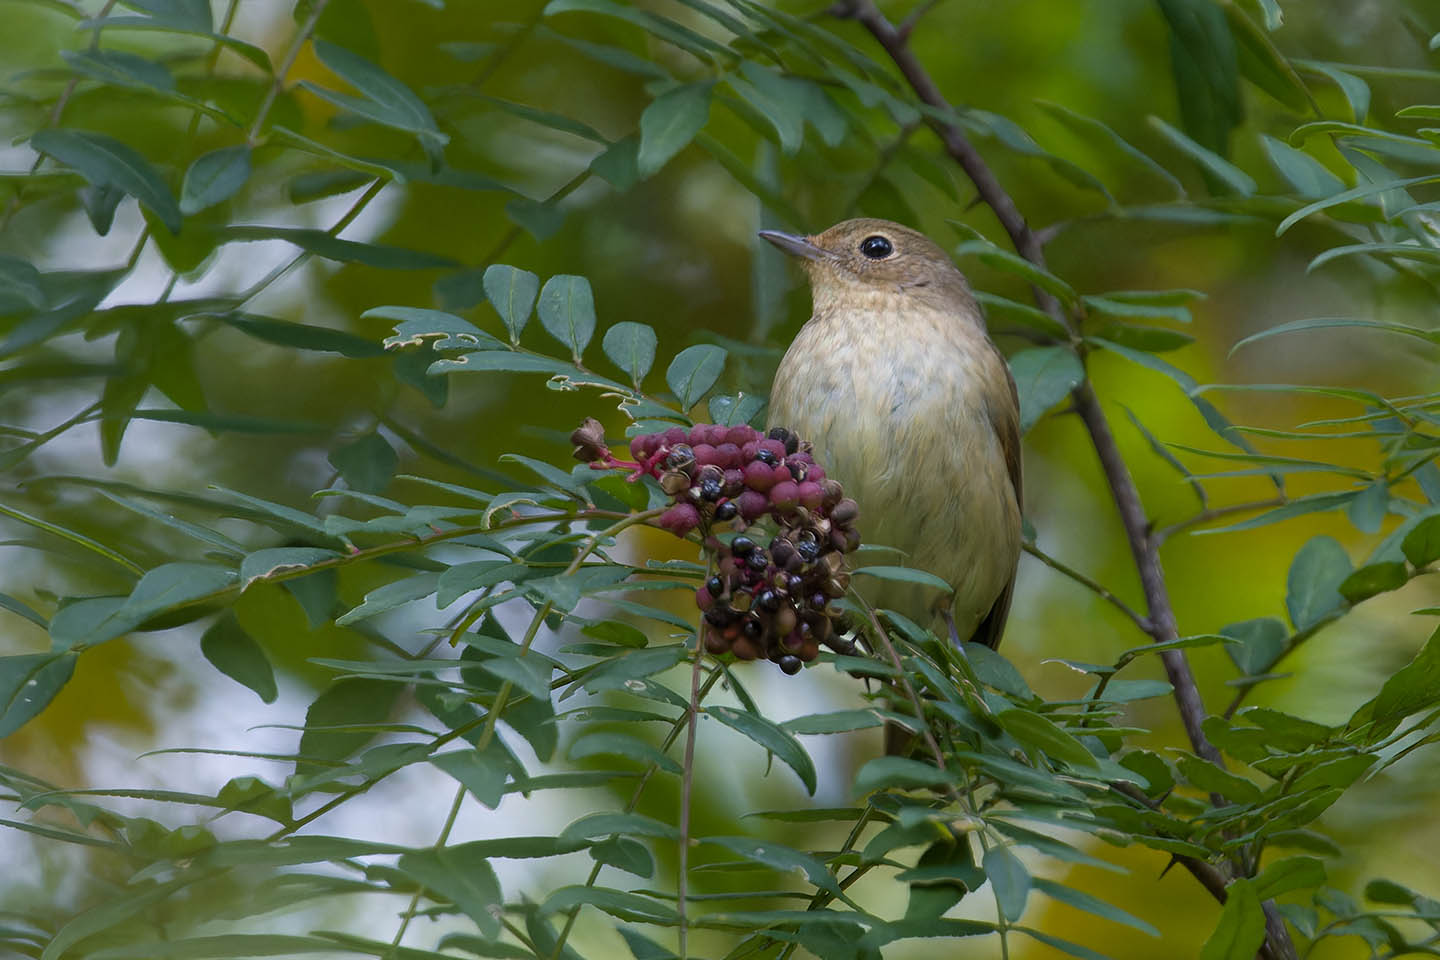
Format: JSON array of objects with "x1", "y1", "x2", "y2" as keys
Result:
[{"x1": 770, "y1": 336, "x2": 1020, "y2": 636}]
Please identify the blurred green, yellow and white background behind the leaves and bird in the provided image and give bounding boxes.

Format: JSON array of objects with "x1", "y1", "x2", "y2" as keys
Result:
[{"x1": 0, "y1": 0, "x2": 1440, "y2": 959}]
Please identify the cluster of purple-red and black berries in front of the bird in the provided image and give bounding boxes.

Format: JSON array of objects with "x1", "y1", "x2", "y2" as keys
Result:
[{"x1": 570, "y1": 419, "x2": 860, "y2": 674}]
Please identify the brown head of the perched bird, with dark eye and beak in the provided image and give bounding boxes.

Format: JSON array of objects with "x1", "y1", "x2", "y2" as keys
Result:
[{"x1": 760, "y1": 219, "x2": 979, "y2": 321}]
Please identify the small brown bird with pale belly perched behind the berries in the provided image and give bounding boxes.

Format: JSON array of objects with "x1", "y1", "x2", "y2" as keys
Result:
[{"x1": 760, "y1": 220, "x2": 1021, "y2": 648}]
